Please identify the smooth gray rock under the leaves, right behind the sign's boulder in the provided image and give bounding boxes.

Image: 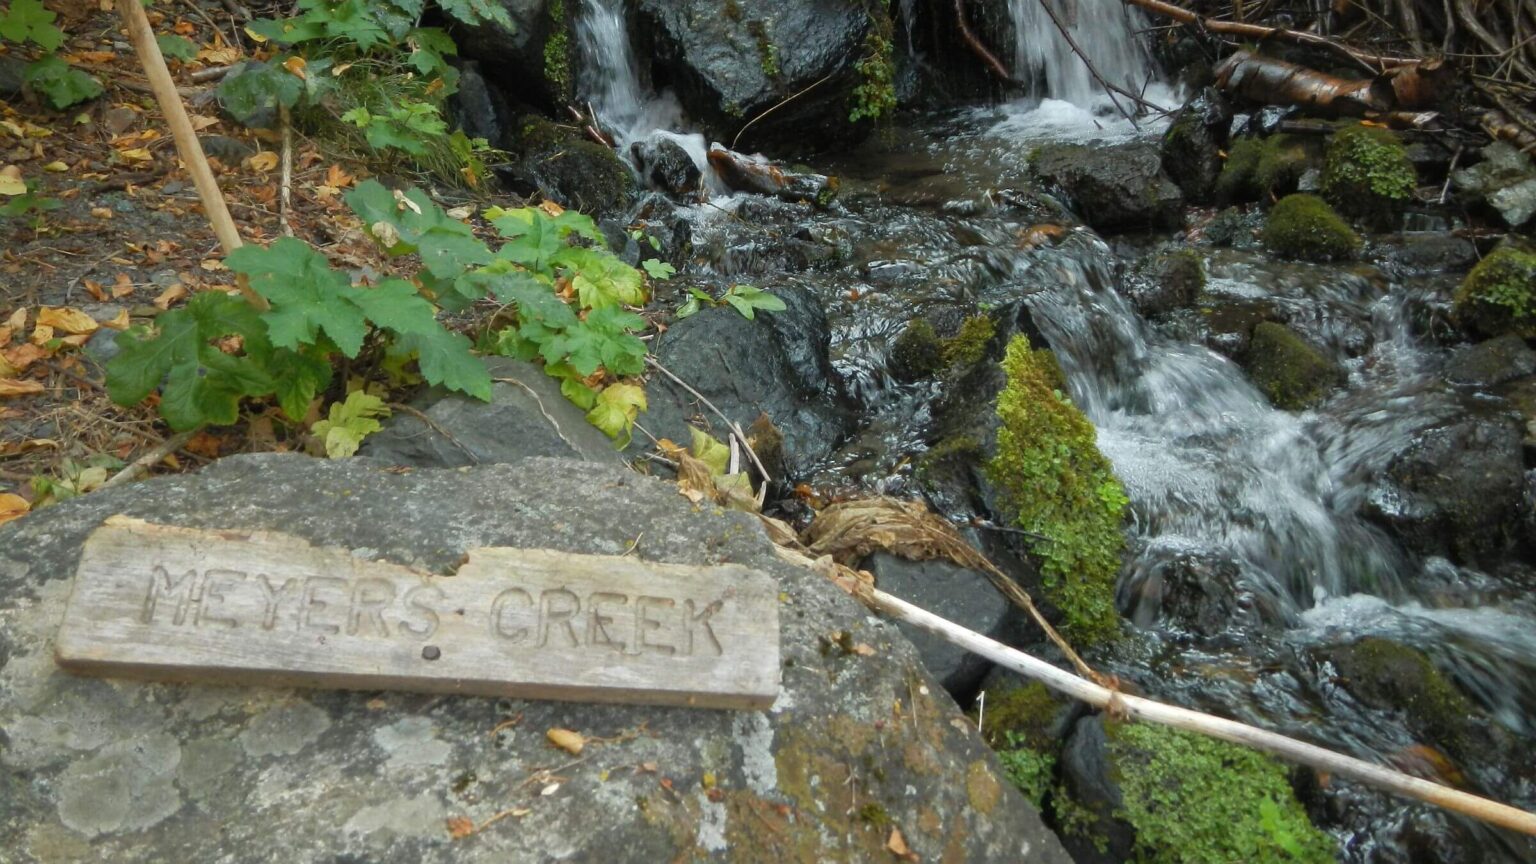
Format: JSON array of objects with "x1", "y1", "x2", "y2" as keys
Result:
[{"x1": 359, "y1": 358, "x2": 622, "y2": 467}]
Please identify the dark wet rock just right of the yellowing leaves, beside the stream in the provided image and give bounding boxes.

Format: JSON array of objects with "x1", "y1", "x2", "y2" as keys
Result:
[{"x1": 631, "y1": 284, "x2": 852, "y2": 480}]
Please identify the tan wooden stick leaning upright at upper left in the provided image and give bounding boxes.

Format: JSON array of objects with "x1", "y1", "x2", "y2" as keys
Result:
[{"x1": 117, "y1": 0, "x2": 267, "y2": 309}]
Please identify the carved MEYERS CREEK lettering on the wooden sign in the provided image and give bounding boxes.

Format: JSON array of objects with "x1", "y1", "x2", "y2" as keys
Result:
[{"x1": 138, "y1": 564, "x2": 725, "y2": 656}]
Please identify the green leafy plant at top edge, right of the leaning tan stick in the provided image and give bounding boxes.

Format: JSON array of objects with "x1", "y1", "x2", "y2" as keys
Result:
[{"x1": 227, "y1": 0, "x2": 511, "y2": 186}]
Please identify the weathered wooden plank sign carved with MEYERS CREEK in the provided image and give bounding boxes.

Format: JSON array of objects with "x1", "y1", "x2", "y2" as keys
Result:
[{"x1": 57, "y1": 517, "x2": 779, "y2": 709}]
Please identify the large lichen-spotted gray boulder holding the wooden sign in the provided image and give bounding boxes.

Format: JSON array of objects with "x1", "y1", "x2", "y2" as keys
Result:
[{"x1": 0, "y1": 455, "x2": 1068, "y2": 864}]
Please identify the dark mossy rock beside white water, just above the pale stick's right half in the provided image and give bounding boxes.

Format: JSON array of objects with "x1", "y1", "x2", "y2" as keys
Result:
[{"x1": 1332, "y1": 636, "x2": 1476, "y2": 755}]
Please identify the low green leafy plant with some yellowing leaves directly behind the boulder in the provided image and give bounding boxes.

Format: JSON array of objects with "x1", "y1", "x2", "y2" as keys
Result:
[{"x1": 108, "y1": 180, "x2": 648, "y2": 438}]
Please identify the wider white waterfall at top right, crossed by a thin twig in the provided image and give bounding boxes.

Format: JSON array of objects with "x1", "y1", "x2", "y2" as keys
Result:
[{"x1": 1008, "y1": 0, "x2": 1157, "y2": 106}]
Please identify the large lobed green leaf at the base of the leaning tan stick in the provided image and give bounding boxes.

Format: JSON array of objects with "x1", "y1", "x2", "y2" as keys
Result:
[{"x1": 224, "y1": 237, "x2": 369, "y2": 357}]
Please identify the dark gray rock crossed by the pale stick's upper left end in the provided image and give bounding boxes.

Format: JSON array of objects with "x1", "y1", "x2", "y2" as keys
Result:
[{"x1": 862, "y1": 552, "x2": 1025, "y2": 704}]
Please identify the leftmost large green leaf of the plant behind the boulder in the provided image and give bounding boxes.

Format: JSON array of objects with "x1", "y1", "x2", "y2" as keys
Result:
[{"x1": 106, "y1": 291, "x2": 273, "y2": 430}]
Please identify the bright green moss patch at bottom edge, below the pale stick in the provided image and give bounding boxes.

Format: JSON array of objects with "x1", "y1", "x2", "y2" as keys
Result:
[{"x1": 1109, "y1": 724, "x2": 1335, "y2": 864}]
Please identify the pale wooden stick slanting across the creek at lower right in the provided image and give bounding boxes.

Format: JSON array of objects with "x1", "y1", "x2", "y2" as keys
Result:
[{"x1": 860, "y1": 587, "x2": 1536, "y2": 836}]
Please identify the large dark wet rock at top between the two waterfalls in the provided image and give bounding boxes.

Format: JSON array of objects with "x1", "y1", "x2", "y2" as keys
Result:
[{"x1": 634, "y1": 0, "x2": 894, "y2": 154}]
